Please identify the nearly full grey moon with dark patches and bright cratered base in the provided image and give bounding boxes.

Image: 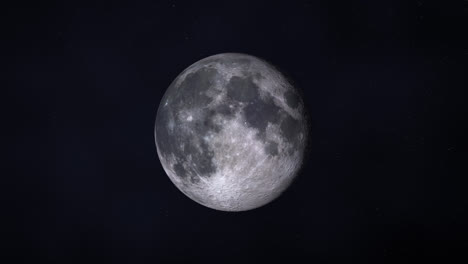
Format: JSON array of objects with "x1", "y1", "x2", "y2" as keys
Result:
[{"x1": 154, "y1": 53, "x2": 308, "y2": 211}]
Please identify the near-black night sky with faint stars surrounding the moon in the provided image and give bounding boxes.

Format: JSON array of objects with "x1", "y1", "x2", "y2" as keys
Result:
[{"x1": 0, "y1": 0, "x2": 468, "y2": 263}]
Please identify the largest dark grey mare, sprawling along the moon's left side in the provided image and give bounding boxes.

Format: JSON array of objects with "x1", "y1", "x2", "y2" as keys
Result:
[{"x1": 155, "y1": 68, "x2": 227, "y2": 182}]
